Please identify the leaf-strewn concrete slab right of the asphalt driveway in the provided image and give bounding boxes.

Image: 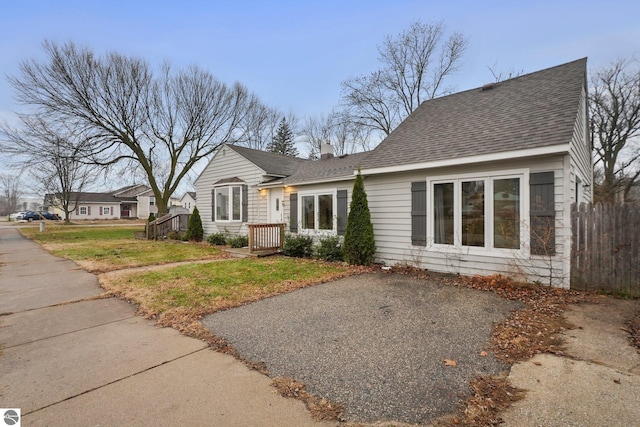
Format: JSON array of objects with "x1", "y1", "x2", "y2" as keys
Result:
[{"x1": 501, "y1": 298, "x2": 640, "y2": 427}]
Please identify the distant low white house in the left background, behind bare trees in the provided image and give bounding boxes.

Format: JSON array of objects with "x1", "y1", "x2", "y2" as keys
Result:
[{"x1": 45, "y1": 184, "x2": 158, "y2": 220}]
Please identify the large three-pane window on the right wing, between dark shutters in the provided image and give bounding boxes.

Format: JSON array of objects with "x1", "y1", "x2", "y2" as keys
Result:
[{"x1": 428, "y1": 173, "x2": 524, "y2": 249}]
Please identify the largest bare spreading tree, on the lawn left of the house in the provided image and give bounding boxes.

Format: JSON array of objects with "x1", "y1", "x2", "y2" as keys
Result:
[{"x1": 9, "y1": 42, "x2": 252, "y2": 214}]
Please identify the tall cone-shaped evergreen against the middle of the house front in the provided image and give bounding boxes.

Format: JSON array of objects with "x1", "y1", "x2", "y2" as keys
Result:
[{"x1": 342, "y1": 171, "x2": 376, "y2": 265}]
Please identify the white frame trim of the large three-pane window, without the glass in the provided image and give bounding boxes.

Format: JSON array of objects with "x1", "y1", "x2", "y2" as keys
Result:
[{"x1": 427, "y1": 169, "x2": 530, "y2": 257}]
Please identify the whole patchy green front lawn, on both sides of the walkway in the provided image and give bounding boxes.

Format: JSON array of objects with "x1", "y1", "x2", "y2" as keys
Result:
[{"x1": 21, "y1": 226, "x2": 358, "y2": 324}]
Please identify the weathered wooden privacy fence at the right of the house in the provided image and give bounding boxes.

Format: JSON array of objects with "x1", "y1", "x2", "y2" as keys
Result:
[{"x1": 571, "y1": 203, "x2": 640, "y2": 296}]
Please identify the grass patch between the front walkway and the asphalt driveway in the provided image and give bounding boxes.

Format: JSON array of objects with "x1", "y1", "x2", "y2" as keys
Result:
[{"x1": 100, "y1": 257, "x2": 354, "y2": 329}]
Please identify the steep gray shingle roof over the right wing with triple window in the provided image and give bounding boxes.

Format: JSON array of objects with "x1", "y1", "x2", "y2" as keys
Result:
[{"x1": 362, "y1": 58, "x2": 587, "y2": 169}]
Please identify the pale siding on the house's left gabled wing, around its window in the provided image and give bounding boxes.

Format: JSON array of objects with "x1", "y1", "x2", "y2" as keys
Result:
[{"x1": 195, "y1": 148, "x2": 267, "y2": 236}]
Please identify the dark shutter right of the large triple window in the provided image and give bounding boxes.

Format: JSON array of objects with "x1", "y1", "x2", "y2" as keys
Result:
[{"x1": 529, "y1": 171, "x2": 556, "y2": 256}]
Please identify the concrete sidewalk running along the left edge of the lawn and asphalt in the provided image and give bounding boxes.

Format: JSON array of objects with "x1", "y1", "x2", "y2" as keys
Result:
[{"x1": 0, "y1": 227, "x2": 335, "y2": 426}]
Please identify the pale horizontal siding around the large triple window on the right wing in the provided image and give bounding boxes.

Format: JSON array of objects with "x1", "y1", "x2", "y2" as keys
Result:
[{"x1": 364, "y1": 155, "x2": 570, "y2": 286}]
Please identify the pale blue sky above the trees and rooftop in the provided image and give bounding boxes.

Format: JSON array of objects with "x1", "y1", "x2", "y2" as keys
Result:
[{"x1": 0, "y1": 0, "x2": 640, "y2": 125}]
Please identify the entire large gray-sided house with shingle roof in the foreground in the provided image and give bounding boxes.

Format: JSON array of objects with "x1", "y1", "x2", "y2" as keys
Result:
[{"x1": 196, "y1": 58, "x2": 593, "y2": 287}]
